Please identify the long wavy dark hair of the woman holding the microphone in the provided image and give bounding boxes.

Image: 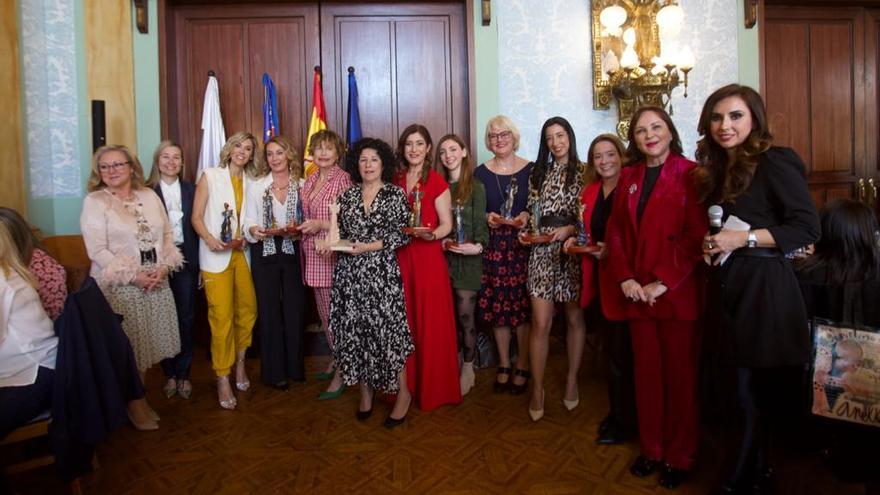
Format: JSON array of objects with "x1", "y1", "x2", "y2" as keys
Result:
[{"x1": 694, "y1": 84, "x2": 773, "y2": 203}]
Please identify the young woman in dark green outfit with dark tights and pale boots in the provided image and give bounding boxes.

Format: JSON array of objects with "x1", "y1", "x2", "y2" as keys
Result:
[{"x1": 434, "y1": 134, "x2": 489, "y2": 395}]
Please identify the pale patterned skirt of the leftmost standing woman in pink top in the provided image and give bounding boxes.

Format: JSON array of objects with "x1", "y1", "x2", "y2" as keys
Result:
[{"x1": 102, "y1": 281, "x2": 180, "y2": 372}]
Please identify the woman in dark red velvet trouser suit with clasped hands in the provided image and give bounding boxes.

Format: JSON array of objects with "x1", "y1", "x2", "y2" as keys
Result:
[{"x1": 602, "y1": 107, "x2": 708, "y2": 489}]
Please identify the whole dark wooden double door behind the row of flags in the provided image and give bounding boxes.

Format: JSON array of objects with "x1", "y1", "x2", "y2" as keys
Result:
[{"x1": 160, "y1": 0, "x2": 470, "y2": 177}]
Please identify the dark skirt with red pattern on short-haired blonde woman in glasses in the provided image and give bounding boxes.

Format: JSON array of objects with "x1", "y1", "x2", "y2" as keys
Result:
[{"x1": 477, "y1": 225, "x2": 530, "y2": 328}]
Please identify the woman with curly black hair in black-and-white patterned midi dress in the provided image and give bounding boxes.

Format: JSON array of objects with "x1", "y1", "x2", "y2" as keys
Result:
[{"x1": 319, "y1": 138, "x2": 414, "y2": 428}]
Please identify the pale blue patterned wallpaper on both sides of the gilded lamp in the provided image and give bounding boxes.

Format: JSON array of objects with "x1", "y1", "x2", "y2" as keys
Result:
[{"x1": 498, "y1": 0, "x2": 740, "y2": 160}]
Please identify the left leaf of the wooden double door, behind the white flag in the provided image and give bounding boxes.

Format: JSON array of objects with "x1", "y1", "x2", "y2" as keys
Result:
[{"x1": 164, "y1": 4, "x2": 319, "y2": 178}]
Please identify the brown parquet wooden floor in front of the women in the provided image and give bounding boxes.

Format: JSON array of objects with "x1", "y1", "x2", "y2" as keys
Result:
[{"x1": 1, "y1": 337, "x2": 863, "y2": 495}]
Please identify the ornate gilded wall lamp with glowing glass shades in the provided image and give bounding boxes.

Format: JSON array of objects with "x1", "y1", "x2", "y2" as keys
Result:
[{"x1": 591, "y1": 0, "x2": 694, "y2": 139}]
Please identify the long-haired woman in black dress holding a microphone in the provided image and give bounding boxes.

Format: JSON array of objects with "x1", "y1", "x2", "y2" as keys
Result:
[{"x1": 695, "y1": 84, "x2": 819, "y2": 493}]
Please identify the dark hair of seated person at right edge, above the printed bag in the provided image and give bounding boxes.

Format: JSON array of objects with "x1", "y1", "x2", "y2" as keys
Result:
[{"x1": 798, "y1": 199, "x2": 880, "y2": 285}]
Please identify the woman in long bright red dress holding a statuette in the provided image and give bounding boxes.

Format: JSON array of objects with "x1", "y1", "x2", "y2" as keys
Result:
[{"x1": 394, "y1": 124, "x2": 461, "y2": 414}]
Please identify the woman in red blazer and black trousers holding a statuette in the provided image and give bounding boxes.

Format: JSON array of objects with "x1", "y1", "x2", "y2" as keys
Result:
[{"x1": 565, "y1": 134, "x2": 636, "y2": 445}]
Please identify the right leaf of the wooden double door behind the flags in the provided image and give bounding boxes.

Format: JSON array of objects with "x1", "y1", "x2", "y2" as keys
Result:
[{"x1": 321, "y1": 2, "x2": 470, "y2": 149}]
